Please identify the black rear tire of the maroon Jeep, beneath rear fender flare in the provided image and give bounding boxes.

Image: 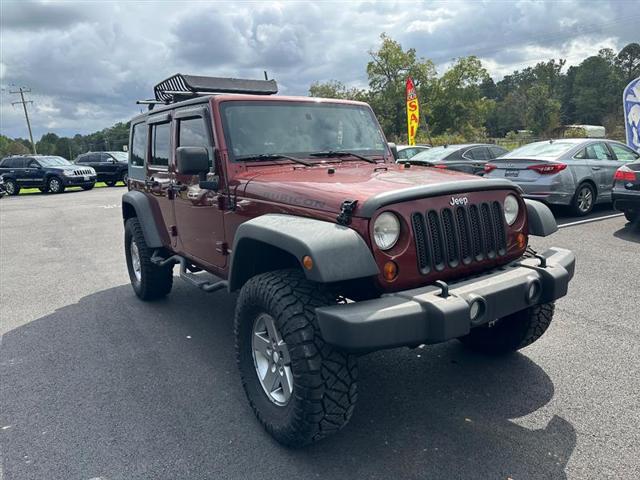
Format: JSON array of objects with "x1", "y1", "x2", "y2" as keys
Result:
[{"x1": 124, "y1": 217, "x2": 173, "y2": 300}]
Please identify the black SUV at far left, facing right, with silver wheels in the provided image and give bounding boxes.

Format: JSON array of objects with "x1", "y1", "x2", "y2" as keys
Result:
[{"x1": 0, "y1": 155, "x2": 96, "y2": 195}]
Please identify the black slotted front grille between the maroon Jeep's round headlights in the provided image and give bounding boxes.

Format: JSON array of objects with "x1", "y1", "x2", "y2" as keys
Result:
[{"x1": 411, "y1": 202, "x2": 507, "y2": 275}]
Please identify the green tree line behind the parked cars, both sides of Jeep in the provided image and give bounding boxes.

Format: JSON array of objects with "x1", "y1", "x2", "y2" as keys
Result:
[{"x1": 0, "y1": 33, "x2": 640, "y2": 159}]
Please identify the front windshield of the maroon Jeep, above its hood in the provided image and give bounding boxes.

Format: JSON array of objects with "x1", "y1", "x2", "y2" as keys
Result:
[{"x1": 221, "y1": 101, "x2": 386, "y2": 160}]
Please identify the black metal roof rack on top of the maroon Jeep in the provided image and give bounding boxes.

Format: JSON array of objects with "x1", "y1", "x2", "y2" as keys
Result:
[{"x1": 151, "y1": 73, "x2": 278, "y2": 103}]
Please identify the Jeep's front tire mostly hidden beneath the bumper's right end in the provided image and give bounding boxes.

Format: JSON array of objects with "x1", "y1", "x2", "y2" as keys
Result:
[{"x1": 459, "y1": 303, "x2": 555, "y2": 355}]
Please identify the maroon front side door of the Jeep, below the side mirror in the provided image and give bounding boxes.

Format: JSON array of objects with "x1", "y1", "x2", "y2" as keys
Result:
[{"x1": 174, "y1": 106, "x2": 227, "y2": 268}]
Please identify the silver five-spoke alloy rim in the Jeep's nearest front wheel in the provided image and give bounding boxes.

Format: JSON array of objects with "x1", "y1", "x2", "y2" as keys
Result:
[{"x1": 251, "y1": 313, "x2": 293, "y2": 406}]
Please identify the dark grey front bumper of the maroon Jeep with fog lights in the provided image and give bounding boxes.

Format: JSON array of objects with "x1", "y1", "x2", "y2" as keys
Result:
[{"x1": 316, "y1": 248, "x2": 575, "y2": 351}]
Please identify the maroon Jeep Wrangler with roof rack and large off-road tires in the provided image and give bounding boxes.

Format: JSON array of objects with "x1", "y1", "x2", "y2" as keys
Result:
[{"x1": 122, "y1": 74, "x2": 575, "y2": 447}]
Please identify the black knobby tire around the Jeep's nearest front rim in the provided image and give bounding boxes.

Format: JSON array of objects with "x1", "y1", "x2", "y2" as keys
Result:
[{"x1": 234, "y1": 270, "x2": 358, "y2": 447}]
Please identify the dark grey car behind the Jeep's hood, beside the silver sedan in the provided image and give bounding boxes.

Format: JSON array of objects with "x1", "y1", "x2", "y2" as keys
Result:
[{"x1": 399, "y1": 143, "x2": 507, "y2": 175}]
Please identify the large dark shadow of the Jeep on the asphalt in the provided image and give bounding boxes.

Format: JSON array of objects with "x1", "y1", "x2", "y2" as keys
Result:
[{"x1": 0, "y1": 282, "x2": 576, "y2": 480}]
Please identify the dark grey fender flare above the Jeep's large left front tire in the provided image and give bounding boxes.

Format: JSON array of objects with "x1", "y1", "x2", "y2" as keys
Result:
[{"x1": 229, "y1": 214, "x2": 379, "y2": 291}]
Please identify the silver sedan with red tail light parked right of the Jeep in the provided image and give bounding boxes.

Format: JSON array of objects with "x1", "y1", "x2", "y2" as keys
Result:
[{"x1": 485, "y1": 138, "x2": 640, "y2": 216}]
